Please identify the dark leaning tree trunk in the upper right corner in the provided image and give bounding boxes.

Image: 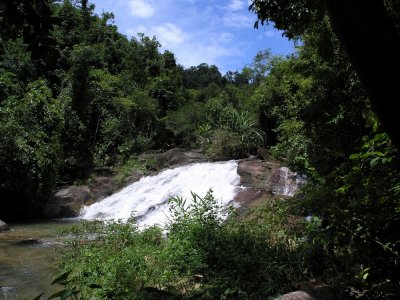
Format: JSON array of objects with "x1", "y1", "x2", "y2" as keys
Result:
[{"x1": 325, "y1": 0, "x2": 400, "y2": 148}]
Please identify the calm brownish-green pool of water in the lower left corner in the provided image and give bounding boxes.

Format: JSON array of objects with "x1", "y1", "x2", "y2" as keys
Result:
[{"x1": 0, "y1": 219, "x2": 78, "y2": 300}]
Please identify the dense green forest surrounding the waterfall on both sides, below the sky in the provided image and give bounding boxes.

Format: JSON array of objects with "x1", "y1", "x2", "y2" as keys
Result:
[{"x1": 0, "y1": 0, "x2": 400, "y2": 299}]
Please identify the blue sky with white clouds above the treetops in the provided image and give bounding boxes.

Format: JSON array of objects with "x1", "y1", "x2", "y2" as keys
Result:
[{"x1": 90, "y1": 0, "x2": 294, "y2": 74}]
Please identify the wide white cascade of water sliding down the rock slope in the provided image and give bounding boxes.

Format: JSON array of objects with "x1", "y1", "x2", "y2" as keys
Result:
[{"x1": 81, "y1": 161, "x2": 240, "y2": 226}]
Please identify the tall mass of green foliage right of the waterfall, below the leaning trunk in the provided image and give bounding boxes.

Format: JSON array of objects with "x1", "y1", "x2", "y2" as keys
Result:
[{"x1": 249, "y1": 0, "x2": 400, "y2": 299}]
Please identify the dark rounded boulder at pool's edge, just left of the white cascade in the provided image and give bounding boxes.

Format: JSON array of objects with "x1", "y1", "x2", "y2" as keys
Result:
[{"x1": 44, "y1": 186, "x2": 91, "y2": 218}]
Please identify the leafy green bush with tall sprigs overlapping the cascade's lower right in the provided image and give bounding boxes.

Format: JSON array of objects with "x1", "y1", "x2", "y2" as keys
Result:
[{"x1": 163, "y1": 192, "x2": 310, "y2": 299}]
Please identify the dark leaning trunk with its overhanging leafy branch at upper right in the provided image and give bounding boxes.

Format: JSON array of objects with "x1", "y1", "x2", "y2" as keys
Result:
[{"x1": 249, "y1": 0, "x2": 400, "y2": 147}]
